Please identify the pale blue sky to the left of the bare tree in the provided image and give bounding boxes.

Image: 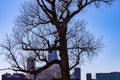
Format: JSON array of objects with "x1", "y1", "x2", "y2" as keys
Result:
[{"x1": 0, "y1": 0, "x2": 25, "y2": 80}]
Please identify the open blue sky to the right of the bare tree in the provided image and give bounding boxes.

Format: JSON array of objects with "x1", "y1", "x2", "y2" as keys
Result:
[{"x1": 78, "y1": 0, "x2": 120, "y2": 79}]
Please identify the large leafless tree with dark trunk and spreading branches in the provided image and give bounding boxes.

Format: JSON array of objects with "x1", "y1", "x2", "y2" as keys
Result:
[{"x1": 1, "y1": 0, "x2": 112, "y2": 80}]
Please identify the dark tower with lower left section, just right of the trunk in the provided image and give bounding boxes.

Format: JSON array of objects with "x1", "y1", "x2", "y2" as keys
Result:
[{"x1": 71, "y1": 67, "x2": 81, "y2": 80}]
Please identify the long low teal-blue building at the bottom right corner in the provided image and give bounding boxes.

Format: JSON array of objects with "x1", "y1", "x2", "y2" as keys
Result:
[{"x1": 96, "y1": 72, "x2": 120, "y2": 80}]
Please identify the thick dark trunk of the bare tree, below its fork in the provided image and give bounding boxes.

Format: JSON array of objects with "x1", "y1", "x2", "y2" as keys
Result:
[{"x1": 58, "y1": 26, "x2": 70, "y2": 80}]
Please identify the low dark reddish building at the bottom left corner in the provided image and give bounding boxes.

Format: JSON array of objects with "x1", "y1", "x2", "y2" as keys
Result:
[{"x1": 2, "y1": 73, "x2": 30, "y2": 80}]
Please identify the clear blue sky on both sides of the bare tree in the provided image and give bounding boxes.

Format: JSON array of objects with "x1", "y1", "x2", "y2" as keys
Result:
[{"x1": 0, "y1": 0, "x2": 120, "y2": 80}]
